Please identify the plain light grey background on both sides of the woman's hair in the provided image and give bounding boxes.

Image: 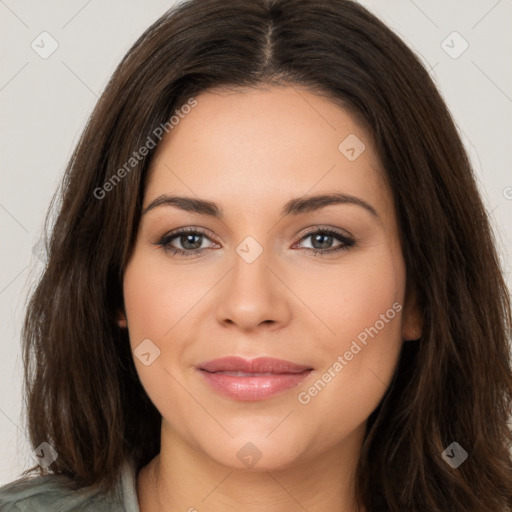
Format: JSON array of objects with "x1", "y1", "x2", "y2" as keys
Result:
[{"x1": 0, "y1": 0, "x2": 512, "y2": 485}]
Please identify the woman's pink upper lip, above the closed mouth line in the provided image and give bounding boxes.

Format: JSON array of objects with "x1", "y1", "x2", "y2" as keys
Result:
[{"x1": 199, "y1": 356, "x2": 313, "y2": 373}]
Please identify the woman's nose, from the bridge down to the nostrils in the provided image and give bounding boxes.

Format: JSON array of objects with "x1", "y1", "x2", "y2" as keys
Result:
[{"x1": 216, "y1": 240, "x2": 293, "y2": 332}]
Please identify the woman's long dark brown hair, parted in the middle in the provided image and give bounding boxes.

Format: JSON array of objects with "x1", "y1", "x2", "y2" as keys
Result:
[{"x1": 16, "y1": 0, "x2": 512, "y2": 512}]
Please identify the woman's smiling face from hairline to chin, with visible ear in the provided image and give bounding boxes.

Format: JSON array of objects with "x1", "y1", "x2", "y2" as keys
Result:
[{"x1": 121, "y1": 87, "x2": 419, "y2": 470}]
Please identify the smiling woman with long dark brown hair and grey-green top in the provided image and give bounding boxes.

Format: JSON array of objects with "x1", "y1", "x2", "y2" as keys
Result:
[{"x1": 0, "y1": 0, "x2": 512, "y2": 512}]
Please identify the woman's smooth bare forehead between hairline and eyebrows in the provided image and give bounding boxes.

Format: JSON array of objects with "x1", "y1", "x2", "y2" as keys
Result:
[{"x1": 144, "y1": 86, "x2": 393, "y2": 228}]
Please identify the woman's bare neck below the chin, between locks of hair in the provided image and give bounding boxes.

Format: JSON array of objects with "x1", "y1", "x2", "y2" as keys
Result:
[{"x1": 137, "y1": 420, "x2": 364, "y2": 512}]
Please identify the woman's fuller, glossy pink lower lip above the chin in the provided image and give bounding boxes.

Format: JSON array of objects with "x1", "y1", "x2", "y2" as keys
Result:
[{"x1": 201, "y1": 370, "x2": 312, "y2": 402}]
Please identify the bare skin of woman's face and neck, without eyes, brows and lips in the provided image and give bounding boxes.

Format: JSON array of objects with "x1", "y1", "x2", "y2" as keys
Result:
[{"x1": 120, "y1": 86, "x2": 421, "y2": 512}]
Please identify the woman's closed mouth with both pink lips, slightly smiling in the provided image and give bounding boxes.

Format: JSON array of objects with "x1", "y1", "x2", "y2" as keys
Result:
[{"x1": 198, "y1": 356, "x2": 313, "y2": 402}]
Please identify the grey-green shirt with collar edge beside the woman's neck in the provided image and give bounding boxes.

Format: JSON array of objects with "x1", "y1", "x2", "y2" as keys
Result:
[{"x1": 0, "y1": 463, "x2": 140, "y2": 512}]
